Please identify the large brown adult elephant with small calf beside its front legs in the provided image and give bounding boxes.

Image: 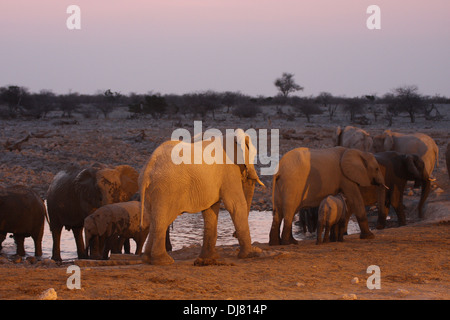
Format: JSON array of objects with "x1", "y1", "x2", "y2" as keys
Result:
[{"x1": 269, "y1": 147, "x2": 385, "y2": 245}]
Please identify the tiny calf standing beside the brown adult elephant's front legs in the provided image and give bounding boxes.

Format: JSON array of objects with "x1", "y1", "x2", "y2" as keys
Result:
[{"x1": 316, "y1": 193, "x2": 347, "y2": 244}]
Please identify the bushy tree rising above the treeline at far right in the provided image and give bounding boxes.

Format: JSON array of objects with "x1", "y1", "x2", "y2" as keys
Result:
[{"x1": 393, "y1": 86, "x2": 424, "y2": 123}]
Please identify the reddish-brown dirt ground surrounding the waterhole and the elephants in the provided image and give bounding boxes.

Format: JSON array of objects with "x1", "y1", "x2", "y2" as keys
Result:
[{"x1": 0, "y1": 108, "x2": 450, "y2": 300}]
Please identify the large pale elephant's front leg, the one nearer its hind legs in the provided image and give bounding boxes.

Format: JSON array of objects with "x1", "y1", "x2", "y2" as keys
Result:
[{"x1": 200, "y1": 202, "x2": 220, "y2": 259}]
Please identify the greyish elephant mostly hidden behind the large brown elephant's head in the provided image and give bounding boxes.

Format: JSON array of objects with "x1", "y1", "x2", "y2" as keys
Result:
[{"x1": 334, "y1": 126, "x2": 373, "y2": 152}]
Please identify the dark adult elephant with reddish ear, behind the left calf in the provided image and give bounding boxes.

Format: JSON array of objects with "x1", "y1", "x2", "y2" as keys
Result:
[{"x1": 47, "y1": 165, "x2": 139, "y2": 261}]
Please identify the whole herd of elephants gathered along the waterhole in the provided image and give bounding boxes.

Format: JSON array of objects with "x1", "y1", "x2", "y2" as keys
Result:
[{"x1": 0, "y1": 126, "x2": 444, "y2": 265}]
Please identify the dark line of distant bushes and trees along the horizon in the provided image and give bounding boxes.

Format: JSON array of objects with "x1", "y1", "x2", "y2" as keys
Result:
[{"x1": 0, "y1": 85, "x2": 450, "y2": 124}]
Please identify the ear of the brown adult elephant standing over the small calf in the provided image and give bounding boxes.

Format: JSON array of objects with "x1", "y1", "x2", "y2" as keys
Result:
[{"x1": 341, "y1": 149, "x2": 371, "y2": 187}]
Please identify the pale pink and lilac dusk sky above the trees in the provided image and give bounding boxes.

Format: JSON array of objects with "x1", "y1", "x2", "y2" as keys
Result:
[{"x1": 0, "y1": 0, "x2": 450, "y2": 96}]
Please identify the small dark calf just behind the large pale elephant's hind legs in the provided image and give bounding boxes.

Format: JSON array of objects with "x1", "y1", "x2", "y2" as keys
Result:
[{"x1": 84, "y1": 201, "x2": 149, "y2": 259}]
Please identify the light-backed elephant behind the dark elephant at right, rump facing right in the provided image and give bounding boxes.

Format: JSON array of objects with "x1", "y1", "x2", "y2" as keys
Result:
[{"x1": 372, "y1": 130, "x2": 439, "y2": 178}]
